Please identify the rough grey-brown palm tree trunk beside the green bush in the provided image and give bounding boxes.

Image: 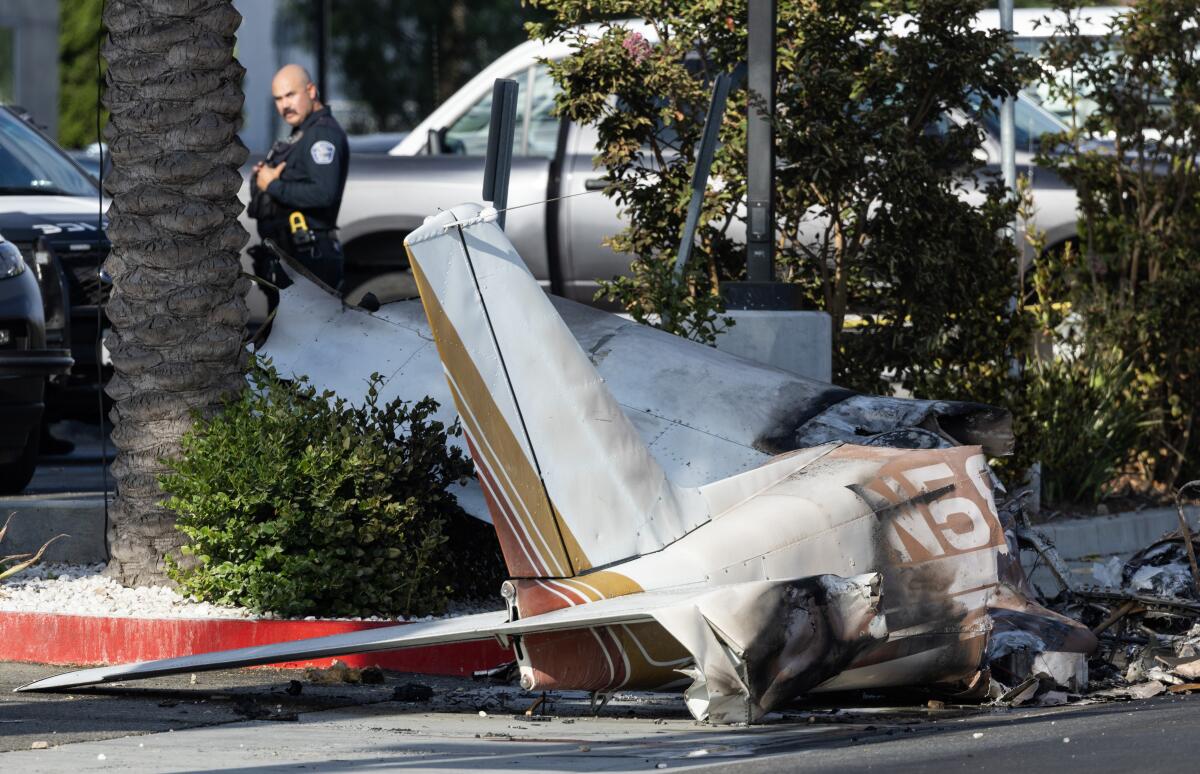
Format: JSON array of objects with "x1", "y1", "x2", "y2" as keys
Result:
[{"x1": 104, "y1": 0, "x2": 247, "y2": 584}]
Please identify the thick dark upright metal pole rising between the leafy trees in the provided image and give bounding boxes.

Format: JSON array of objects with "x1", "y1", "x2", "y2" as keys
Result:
[{"x1": 746, "y1": 0, "x2": 775, "y2": 282}]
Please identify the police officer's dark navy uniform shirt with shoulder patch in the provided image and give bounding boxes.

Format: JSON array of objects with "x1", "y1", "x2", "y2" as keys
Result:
[{"x1": 266, "y1": 107, "x2": 350, "y2": 232}]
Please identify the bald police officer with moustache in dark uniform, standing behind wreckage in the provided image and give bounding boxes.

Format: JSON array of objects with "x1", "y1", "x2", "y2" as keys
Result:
[{"x1": 250, "y1": 65, "x2": 350, "y2": 295}]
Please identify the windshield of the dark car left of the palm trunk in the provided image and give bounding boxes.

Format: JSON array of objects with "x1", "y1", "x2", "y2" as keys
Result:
[{"x1": 0, "y1": 109, "x2": 96, "y2": 196}]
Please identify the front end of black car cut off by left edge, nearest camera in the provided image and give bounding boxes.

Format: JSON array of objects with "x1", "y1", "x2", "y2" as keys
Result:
[{"x1": 0, "y1": 236, "x2": 73, "y2": 494}]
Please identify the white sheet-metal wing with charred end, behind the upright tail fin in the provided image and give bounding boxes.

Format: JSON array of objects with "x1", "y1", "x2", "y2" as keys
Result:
[{"x1": 259, "y1": 258, "x2": 1012, "y2": 521}]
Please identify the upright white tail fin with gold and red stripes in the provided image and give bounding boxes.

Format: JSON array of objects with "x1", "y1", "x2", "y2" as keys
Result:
[{"x1": 404, "y1": 205, "x2": 709, "y2": 577}]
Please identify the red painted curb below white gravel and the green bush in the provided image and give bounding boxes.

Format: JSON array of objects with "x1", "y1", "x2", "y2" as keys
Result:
[{"x1": 0, "y1": 611, "x2": 512, "y2": 674}]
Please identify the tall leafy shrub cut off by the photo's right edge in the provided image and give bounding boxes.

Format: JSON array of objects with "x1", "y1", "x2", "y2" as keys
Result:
[{"x1": 1043, "y1": 0, "x2": 1200, "y2": 486}]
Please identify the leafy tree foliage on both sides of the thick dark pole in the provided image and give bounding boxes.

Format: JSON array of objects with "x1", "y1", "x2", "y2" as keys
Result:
[{"x1": 530, "y1": 0, "x2": 1034, "y2": 379}]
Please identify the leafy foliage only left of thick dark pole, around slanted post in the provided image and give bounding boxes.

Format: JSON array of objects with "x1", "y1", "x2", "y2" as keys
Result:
[{"x1": 529, "y1": 12, "x2": 745, "y2": 342}]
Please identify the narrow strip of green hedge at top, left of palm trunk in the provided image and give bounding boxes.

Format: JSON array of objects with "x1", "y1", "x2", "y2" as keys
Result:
[{"x1": 59, "y1": 0, "x2": 108, "y2": 148}]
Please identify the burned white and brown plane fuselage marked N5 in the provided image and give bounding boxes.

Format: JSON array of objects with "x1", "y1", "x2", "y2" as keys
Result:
[{"x1": 501, "y1": 444, "x2": 1008, "y2": 713}]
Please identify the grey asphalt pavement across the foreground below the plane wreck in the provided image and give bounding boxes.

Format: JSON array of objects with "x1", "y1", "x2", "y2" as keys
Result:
[{"x1": 0, "y1": 664, "x2": 1200, "y2": 774}]
